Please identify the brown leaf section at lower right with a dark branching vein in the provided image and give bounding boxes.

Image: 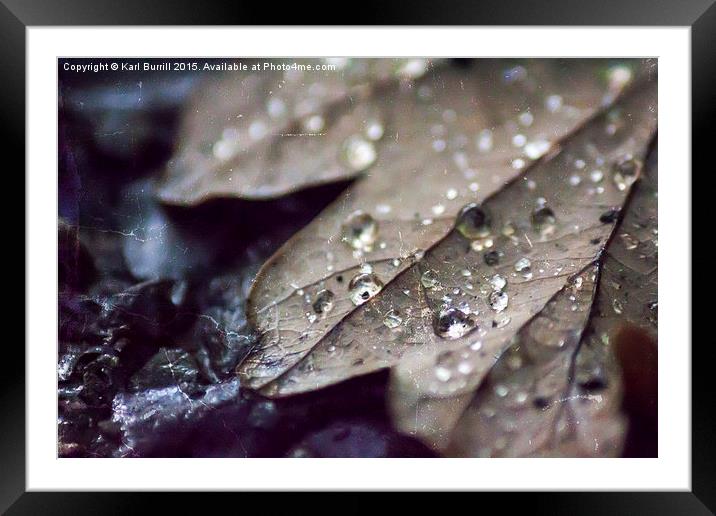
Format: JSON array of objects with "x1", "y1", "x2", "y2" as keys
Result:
[{"x1": 446, "y1": 141, "x2": 657, "y2": 457}]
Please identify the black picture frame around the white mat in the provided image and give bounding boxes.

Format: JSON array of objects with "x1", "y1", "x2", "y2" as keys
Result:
[{"x1": 0, "y1": 0, "x2": 716, "y2": 514}]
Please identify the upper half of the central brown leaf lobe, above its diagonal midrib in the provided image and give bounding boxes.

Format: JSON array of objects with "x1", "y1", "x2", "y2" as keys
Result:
[{"x1": 240, "y1": 61, "x2": 644, "y2": 387}]
